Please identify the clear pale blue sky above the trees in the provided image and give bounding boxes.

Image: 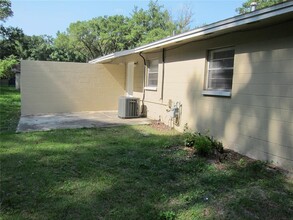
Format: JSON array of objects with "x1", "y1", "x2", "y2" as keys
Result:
[{"x1": 0, "y1": 0, "x2": 245, "y2": 37}]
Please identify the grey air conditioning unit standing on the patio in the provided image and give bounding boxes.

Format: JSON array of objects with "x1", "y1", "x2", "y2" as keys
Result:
[{"x1": 118, "y1": 96, "x2": 140, "y2": 118}]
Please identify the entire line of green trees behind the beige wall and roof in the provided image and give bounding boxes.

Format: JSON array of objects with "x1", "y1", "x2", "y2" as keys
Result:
[{"x1": 0, "y1": 0, "x2": 192, "y2": 71}]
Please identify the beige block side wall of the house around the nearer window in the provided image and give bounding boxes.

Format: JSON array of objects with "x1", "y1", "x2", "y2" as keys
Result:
[{"x1": 136, "y1": 21, "x2": 293, "y2": 171}]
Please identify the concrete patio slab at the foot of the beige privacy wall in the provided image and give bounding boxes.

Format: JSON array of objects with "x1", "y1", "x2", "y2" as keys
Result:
[{"x1": 17, "y1": 111, "x2": 151, "y2": 132}]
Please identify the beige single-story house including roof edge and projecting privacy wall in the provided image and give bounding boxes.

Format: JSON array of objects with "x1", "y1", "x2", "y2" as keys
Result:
[{"x1": 21, "y1": 1, "x2": 293, "y2": 171}]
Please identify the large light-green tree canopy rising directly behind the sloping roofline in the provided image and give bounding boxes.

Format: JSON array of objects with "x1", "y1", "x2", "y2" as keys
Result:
[{"x1": 52, "y1": 1, "x2": 192, "y2": 61}]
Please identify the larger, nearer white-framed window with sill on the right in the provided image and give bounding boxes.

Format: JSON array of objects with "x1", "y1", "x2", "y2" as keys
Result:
[{"x1": 203, "y1": 47, "x2": 234, "y2": 96}]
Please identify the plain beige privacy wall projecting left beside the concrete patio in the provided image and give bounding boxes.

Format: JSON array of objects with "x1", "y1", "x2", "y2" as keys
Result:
[{"x1": 21, "y1": 61, "x2": 125, "y2": 115}]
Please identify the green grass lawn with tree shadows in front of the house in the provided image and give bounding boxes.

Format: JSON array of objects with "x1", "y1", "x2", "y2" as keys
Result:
[{"x1": 0, "y1": 85, "x2": 293, "y2": 219}]
